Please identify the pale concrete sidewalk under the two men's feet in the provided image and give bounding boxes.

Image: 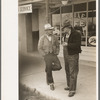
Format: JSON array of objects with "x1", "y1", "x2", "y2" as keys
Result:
[{"x1": 20, "y1": 52, "x2": 96, "y2": 100}]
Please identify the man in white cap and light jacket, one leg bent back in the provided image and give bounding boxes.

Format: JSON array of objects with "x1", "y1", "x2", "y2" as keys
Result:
[{"x1": 38, "y1": 24, "x2": 61, "y2": 90}]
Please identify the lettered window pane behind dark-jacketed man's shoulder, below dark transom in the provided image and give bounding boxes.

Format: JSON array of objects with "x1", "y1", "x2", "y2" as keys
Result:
[{"x1": 74, "y1": 12, "x2": 87, "y2": 46}]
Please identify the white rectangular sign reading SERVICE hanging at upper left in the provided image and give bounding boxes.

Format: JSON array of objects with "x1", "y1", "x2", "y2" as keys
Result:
[{"x1": 18, "y1": 4, "x2": 32, "y2": 14}]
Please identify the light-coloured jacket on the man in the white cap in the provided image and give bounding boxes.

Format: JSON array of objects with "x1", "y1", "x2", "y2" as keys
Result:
[{"x1": 38, "y1": 34, "x2": 60, "y2": 56}]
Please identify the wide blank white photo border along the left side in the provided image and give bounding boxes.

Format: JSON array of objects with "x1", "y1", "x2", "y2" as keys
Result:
[{"x1": 1, "y1": 0, "x2": 18, "y2": 100}]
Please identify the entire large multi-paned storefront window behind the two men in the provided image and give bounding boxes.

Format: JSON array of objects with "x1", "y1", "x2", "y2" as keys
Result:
[{"x1": 52, "y1": 1, "x2": 96, "y2": 47}]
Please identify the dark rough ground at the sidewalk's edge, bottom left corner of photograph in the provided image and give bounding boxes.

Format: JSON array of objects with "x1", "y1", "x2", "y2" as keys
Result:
[{"x1": 19, "y1": 84, "x2": 56, "y2": 100}]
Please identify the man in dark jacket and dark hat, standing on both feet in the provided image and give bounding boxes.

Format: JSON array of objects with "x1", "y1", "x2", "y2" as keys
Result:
[{"x1": 62, "y1": 22, "x2": 81, "y2": 97}]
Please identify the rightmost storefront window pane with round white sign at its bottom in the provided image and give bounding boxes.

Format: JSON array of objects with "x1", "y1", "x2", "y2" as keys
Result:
[{"x1": 87, "y1": 1, "x2": 96, "y2": 47}]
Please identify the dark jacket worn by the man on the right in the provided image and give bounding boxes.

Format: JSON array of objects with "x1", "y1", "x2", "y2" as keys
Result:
[{"x1": 67, "y1": 29, "x2": 82, "y2": 55}]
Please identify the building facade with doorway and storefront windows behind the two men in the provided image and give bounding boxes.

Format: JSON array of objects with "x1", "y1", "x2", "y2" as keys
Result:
[{"x1": 19, "y1": 0, "x2": 96, "y2": 61}]
